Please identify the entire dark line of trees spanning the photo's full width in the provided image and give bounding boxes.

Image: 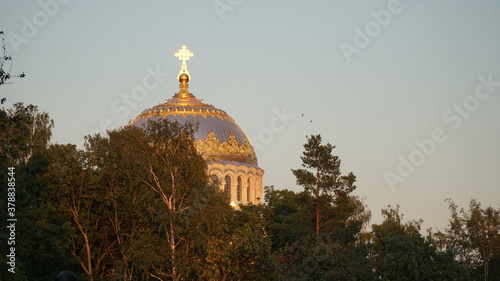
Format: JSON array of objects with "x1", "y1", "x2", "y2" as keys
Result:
[{"x1": 0, "y1": 103, "x2": 500, "y2": 281}]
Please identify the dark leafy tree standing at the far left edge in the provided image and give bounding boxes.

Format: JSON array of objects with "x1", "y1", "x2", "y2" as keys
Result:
[{"x1": 0, "y1": 103, "x2": 56, "y2": 280}]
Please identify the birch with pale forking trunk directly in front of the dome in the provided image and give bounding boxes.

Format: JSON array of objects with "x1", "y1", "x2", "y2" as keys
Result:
[{"x1": 118, "y1": 120, "x2": 208, "y2": 281}]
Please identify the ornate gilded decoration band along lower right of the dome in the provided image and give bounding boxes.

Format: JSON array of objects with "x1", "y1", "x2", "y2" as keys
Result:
[{"x1": 195, "y1": 132, "x2": 257, "y2": 160}]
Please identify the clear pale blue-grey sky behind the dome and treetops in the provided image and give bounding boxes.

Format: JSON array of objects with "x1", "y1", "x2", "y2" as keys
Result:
[{"x1": 0, "y1": 0, "x2": 500, "y2": 229}]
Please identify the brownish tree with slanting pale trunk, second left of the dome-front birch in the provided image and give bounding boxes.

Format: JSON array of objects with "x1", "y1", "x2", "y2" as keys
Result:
[{"x1": 38, "y1": 144, "x2": 113, "y2": 280}]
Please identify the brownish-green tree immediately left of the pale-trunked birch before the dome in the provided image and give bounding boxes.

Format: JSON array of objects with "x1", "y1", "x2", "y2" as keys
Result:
[{"x1": 86, "y1": 128, "x2": 158, "y2": 280}]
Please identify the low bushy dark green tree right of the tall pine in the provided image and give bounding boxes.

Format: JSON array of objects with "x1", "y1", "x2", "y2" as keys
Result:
[{"x1": 370, "y1": 206, "x2": 466, "y2": 280}]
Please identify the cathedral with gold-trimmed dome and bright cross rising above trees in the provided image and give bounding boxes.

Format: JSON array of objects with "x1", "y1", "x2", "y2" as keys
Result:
[{"x1": 131, "y1": 46, "x2": 264, "y2": 203}]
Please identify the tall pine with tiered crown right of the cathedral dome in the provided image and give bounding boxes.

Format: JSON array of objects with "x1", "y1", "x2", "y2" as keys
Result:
[{"x1": 265, "y1": 135, "x2": 372, "y2": 280}]
